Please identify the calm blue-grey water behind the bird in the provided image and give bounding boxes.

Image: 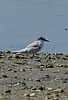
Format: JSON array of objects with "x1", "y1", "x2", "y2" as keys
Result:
[{"x1": 0, "y1": 0, "x2": 68, "y2": 52}]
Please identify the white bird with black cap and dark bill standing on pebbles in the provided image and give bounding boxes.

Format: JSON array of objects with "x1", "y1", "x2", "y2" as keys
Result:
[{"x1": 12, "y1": 37, "x2": 50, "y2": 54}]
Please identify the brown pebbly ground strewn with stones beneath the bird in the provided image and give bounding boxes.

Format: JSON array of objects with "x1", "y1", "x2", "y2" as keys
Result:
[{"x1": 0, "y1": 52, "x2": 68, "y2": 100}]
